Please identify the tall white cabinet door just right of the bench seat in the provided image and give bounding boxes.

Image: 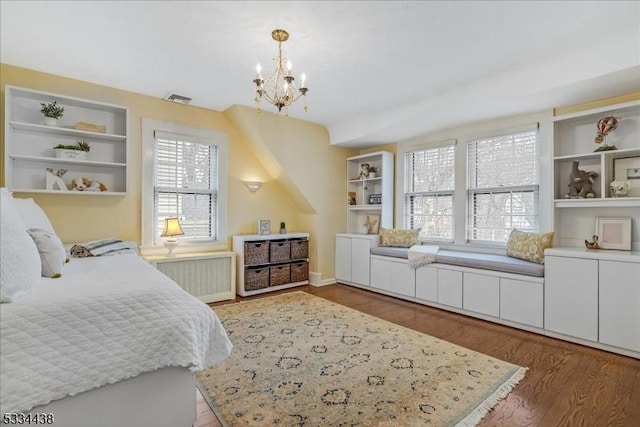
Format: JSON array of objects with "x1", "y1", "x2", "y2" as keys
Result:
[{"x1": 544, "y1": 256, "x2": 598, "y2": 341}]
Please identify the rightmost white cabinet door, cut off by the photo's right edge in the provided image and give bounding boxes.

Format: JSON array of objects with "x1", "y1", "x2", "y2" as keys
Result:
[{"x1": 599, "y1": 261, "x2": 640, "y2": 351}]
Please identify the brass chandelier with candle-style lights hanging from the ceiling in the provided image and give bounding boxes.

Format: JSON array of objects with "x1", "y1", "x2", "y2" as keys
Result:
[{"x1": 253, "y1": 29, "x2": 309, "y2": 112}]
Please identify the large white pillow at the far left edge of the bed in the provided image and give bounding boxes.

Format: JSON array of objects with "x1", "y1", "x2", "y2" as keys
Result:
[{"x1": 0, "y1": 191, "x2": 42, "y2": 302}]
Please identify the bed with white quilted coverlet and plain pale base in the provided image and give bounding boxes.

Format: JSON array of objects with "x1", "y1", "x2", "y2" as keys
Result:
[{"x1": 0, "y1": 191, "x2": 232, "y2": 427}]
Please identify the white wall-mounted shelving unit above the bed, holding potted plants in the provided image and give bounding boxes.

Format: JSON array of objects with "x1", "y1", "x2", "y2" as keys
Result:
[{"x1": 5, "y1": 86, "x2": 128, "y2": 196}]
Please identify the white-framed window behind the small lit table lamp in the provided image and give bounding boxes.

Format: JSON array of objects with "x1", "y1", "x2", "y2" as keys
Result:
[{"x1": 142, "y1": 119, "x2": 227, "y2": 254}]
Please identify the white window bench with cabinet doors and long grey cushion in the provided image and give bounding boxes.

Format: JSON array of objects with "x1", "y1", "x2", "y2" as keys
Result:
[{"x1": 356, "y1": 247, "x2": 544, "y2": 333}]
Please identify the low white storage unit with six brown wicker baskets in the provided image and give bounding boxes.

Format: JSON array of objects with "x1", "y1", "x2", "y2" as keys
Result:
[{"x1": 233, "y1": 232, "x2": 309, "y2": 297}]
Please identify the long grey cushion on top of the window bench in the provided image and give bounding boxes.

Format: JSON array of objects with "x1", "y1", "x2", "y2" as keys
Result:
[{"x1": 371, "y1": 247, "x2": 544, "y2": 277}]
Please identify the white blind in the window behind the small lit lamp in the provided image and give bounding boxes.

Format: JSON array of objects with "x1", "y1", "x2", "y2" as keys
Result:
[{"x1": 153, "y1": 131, "x2": 219, "y2": 244}]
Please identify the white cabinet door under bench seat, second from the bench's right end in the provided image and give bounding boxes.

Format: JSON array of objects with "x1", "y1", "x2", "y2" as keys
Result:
[{"x1": 462, "y1": 273, "x2": 500, "y2": 317}]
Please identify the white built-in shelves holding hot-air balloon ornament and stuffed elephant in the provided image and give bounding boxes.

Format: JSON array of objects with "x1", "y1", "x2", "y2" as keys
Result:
[{"x1": 553, "y1": 101, "x2": 640, "y2": 247}]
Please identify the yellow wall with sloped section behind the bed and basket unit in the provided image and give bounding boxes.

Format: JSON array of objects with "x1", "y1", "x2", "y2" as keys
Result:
[{"x1": 0, "y1": 64, "x2": 353, "y2": 278}]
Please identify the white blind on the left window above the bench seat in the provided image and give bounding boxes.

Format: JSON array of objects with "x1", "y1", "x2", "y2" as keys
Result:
[{"x1": 404, "y1": 143, "x2": 455, "y2": 241}]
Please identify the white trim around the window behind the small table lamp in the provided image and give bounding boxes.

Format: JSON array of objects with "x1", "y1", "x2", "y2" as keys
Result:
[{"x1": 140, "y1": 118, "x2": 228, "y2": 255}]
